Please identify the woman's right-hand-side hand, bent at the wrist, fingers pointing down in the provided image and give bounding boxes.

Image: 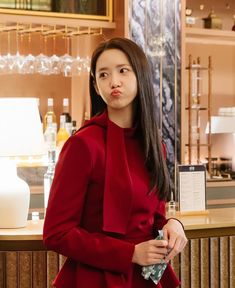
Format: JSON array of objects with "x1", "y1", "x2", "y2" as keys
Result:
[{"x1": 162, "y1": 219, "x2": 188, "y2": 262}]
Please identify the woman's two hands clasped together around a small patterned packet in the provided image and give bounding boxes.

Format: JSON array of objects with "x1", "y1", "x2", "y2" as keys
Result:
[{"x1": 132, "y1": 219, "x2": 187, "y2": 266}]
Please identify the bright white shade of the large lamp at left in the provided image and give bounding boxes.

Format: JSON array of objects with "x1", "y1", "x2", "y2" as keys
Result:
[{"x1": 0, "y1": 98, "x2": 45, "y2": 156}]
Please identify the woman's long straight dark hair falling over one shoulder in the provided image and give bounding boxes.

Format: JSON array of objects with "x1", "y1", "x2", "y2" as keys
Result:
[{"x1": 89, "y1": 38, "x2": 170, "y2": 200}]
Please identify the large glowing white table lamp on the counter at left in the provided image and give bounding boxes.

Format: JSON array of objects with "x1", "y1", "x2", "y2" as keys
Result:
[{"x1": 0, "y1": 97, "x2": 45, "y2": 228}]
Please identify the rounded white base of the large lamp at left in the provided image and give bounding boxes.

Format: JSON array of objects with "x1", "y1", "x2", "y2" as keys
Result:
[{"x1": 0, "y1": 161, "x2": 30, "y2": 228}]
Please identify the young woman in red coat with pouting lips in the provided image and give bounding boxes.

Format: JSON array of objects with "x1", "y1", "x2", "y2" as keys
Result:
[{"x1": 43, "y1": 38, "x2": 187, "y2": 288}]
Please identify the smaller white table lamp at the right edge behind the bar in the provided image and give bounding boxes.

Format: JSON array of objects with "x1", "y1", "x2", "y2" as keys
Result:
[{"x1": 206, "y1": 116, "x2": 235, "y2": 171}]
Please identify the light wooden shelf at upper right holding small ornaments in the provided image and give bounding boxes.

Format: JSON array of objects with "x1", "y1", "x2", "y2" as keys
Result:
[{"x1": 185, "y1": 27, "x2": 235, "y2": 46}]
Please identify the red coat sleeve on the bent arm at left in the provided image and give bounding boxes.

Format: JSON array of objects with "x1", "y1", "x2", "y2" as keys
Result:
[{"x1": 43, "y1": 135, "x2": 134, "y2": 273}]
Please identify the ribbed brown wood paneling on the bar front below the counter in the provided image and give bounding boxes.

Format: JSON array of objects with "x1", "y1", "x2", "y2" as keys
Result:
[{"x1": 0, "y1": 236, "x2": 235, "y2": 288}]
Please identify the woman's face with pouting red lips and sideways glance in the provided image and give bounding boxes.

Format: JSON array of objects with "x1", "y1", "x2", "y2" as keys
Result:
[{"x1": 95, "y1": 49, "x2": 137, "y2": 117}]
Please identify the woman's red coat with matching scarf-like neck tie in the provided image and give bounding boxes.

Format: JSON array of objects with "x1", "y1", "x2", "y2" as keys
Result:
[{"x1": 43, "y1": 113, "x2": 179, "y2": 288}]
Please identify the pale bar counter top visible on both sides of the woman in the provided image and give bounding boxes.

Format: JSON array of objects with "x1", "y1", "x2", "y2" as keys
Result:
[{"x1": 0, "y1": 208, "x2": 235, "y2": 241}]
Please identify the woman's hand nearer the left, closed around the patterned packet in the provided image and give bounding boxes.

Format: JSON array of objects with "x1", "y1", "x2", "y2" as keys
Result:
[{"x1": 132, "y1": 240, "x2": 168, "y2": 266}]
